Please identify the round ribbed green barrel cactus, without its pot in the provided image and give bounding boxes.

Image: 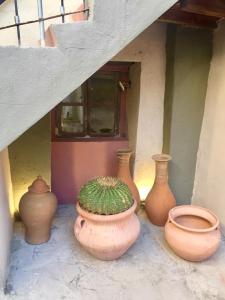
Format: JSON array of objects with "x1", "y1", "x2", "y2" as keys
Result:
[{"x1": 79, "y1": 176, "x2": 133, "y2": 215}]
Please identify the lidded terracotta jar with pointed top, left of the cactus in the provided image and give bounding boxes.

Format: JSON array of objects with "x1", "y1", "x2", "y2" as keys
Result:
[{"x1": 19, "y1": 176, "x2": 57, "y2": 245}]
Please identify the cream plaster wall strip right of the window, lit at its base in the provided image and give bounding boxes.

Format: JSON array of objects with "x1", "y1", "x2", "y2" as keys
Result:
[{"x1": 114, "y1": 22, "x2": 166, "y2": 199}]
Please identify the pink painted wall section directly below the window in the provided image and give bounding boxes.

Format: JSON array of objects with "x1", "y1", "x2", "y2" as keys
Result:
[{"x1": 51, "y1": 140, "x2": 128, "y2": 204}]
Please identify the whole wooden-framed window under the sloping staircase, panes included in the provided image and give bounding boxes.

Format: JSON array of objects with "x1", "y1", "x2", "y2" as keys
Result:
[{"x1": 52, "y1": 63, "x2": 129, "y2": 140}]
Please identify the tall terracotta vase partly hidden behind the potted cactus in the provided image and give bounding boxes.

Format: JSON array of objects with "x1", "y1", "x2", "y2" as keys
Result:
[{"x1": 117, "y1": 149, "x2": 141, "y2": 212}]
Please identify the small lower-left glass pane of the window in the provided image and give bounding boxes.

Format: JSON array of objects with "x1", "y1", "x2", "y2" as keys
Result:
[{"x1": 61, "y1": 106, "x2": 84, "y2": 133}]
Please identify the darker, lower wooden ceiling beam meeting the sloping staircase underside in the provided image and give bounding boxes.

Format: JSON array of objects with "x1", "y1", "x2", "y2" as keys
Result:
[{"x1": 158, "y1": 5, "x2": 219, "y2": 29}]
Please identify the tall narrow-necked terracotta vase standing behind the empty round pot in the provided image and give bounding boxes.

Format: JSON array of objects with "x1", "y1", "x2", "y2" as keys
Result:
[{"x1": 145, "y1": 154, "x2": 176, "y2": 226}]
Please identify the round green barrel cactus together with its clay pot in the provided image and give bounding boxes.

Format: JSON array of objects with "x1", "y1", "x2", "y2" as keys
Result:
[{"x1": 74, "y1": 176, "x2": 140, "y2": 260}]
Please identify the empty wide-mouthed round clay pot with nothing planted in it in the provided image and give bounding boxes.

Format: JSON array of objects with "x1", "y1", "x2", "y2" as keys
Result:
[{"x1": 165, "y1": 205, "x2": 221, "y2": 261}]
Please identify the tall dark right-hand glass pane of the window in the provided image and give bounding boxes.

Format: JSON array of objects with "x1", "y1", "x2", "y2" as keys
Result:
[{"x1": 88, "y1": 74, "x2": 118, "y2": 135}]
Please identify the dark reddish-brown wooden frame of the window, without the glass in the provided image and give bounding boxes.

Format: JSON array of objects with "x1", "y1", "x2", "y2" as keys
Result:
[{"x1": 51, "y1": 62, "x2": 131, "y2": 142}]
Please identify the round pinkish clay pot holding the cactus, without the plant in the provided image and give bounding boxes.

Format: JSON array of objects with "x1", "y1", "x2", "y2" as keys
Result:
[{"x1": 74, "y1": 202, "x2": 140, "y2": 260}]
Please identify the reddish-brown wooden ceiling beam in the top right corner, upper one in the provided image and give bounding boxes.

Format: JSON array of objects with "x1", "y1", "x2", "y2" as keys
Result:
[{"x1": 180, "y1": 0, "x2": 225, "y2": 18}]
